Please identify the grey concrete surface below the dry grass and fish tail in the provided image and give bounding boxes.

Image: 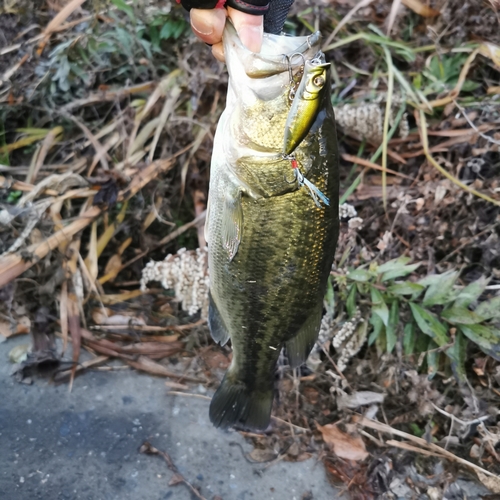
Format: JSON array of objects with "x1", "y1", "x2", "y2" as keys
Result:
[{"x1": 0, "y1": 336, "x2": 339, "y2": 500}]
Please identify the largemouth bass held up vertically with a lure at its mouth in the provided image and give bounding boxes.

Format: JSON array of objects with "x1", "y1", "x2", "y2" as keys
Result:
[{"x1": 206, "y1": 22, "x2": 339, "y2": 429}]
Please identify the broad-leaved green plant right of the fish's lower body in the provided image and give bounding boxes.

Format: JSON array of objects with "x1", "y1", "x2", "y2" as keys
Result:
[{"x1": 327, "y1": 257, "x2": 500, "y2": 382}]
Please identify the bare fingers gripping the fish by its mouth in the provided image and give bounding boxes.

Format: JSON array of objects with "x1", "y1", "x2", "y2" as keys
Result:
[{"x1": 190, "y1": 7, "x2": 263, "y2": 62}]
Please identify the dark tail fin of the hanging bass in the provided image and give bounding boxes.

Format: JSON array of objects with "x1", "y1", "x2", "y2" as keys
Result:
[{"x1": 210, "y1": 374, "x2": 274, "y2": 430}]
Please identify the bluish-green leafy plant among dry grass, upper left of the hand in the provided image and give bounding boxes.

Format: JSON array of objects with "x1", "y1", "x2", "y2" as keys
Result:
[{"x1": 36, "y1": 0, "x2": 189, "y2": 101}]
